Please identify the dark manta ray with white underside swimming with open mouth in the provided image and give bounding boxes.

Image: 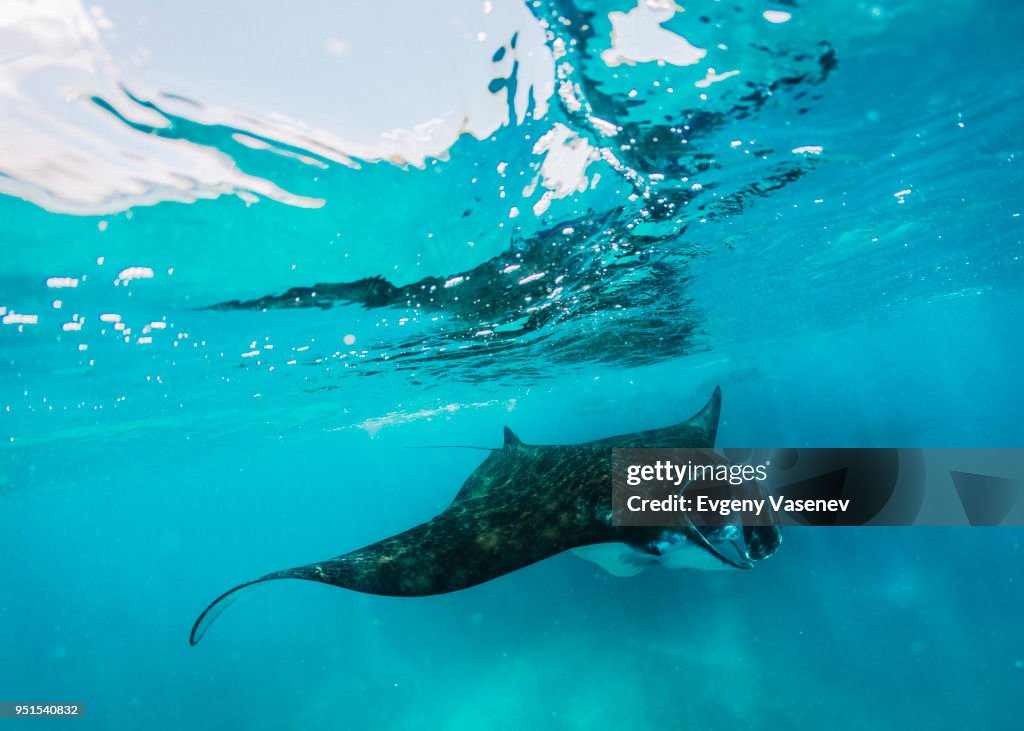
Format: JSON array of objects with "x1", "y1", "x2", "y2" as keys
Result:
[{"x1": 189, "y1": 388, "x2": 781, "y2": 645}]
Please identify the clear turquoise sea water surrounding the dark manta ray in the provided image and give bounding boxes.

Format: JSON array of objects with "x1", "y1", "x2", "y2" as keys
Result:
[{"x1": 0, "y1": 0, "x2": 1024, "y2": 729}]
